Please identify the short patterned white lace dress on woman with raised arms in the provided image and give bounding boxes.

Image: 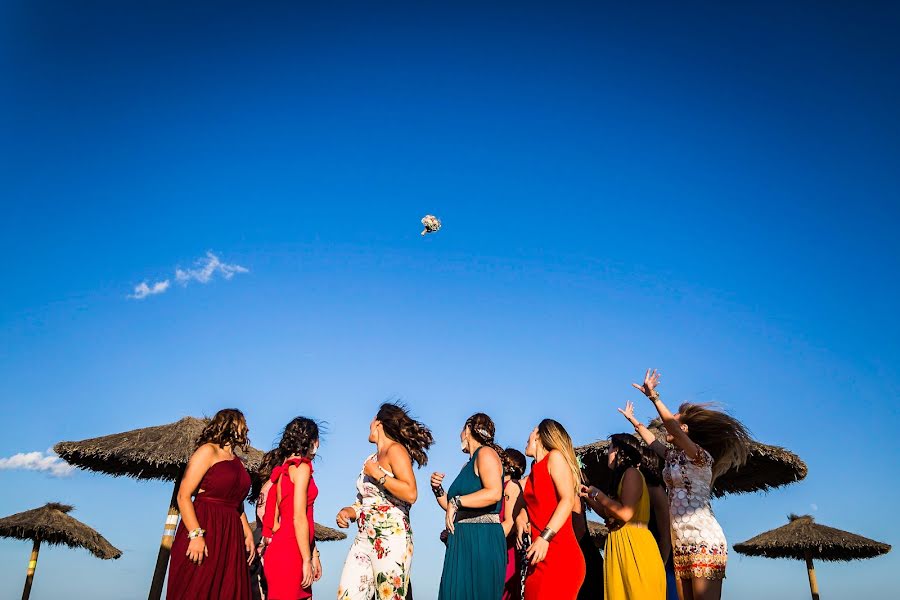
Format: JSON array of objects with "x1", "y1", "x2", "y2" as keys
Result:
[{"x1": 663, "y1": 446, "x2": 728, "y2": 579}]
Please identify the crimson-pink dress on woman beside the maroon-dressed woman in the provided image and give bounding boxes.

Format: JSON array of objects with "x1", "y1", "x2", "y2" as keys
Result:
[{"x1": 263, "y1": 458, "x2": 319, "y2": 600}]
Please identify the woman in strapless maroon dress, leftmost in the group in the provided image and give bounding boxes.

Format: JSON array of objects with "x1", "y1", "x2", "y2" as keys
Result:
[{"x1": 166, "y1": 409, "x2": 256, "y2": 600}]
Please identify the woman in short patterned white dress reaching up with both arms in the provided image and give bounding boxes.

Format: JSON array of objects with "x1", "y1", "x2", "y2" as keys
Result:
[{"x1": 619, "y1": 369, "x2": 750, "y2": 600}]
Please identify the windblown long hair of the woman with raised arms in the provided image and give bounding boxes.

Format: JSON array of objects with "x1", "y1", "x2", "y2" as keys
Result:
[{"x1": 678, "y1": 402, "x2": 752, "y2": 481}]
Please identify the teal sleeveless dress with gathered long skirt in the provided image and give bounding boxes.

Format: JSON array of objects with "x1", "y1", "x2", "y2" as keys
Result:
[{"x1": 438, "y1": 448, "x2": 507, "y2": 600}]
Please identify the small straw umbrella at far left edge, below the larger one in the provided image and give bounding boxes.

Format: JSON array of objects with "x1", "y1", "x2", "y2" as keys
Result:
[{"x1": 0, "y1": 502, "x2": 122, "y2": 600}]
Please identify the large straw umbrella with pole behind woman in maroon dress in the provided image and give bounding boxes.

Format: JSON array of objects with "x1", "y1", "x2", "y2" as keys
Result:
[{"x1": 53, "y1": 417, "x2": 263, "y2": 600}]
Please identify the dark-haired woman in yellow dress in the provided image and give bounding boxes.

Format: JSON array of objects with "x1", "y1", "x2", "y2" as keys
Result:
[{"x1": 581, "y1": 433, "x2": 666, "y2": 600}]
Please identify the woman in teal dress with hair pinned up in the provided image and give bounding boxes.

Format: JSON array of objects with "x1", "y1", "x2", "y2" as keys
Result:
[{"x1": 431, "y1": 413, "x2": 506, "y2": 600}]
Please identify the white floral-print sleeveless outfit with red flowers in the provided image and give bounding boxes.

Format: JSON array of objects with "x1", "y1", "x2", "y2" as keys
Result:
[{"x1": 337, "y1": 454, "x2": 413, "y2": 600}]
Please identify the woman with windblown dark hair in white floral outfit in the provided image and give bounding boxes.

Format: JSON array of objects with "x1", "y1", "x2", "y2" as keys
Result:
[{"x1": 335, "y1": 402, "x2": 434, "y2": 600}]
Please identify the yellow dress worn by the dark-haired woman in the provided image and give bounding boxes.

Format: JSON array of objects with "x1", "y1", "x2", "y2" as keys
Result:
[{"x1": 603, "y1": 474, "x2": 666, "y2": 600}]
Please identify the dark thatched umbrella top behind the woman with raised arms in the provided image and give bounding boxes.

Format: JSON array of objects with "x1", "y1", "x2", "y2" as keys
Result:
[{"x1": 575, "y1": 419, "x2": 807, "y2": 497}]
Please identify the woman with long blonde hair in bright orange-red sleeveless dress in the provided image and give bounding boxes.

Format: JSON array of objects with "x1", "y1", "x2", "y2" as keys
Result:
[{"x1": 516, "y1": 419, "x2": 585, "y2": 600}]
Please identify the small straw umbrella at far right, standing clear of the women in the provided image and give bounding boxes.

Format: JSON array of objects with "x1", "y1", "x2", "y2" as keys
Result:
[{"x1": 734, "y1": 515, "x2": 891, "y2": 600}]
